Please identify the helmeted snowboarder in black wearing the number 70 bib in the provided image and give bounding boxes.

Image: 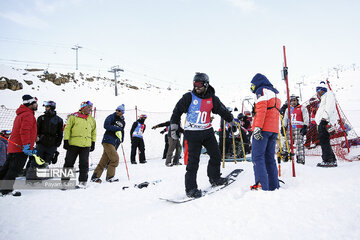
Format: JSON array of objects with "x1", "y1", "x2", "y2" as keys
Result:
[{"x1": 170, "y1": 73, "x2": 234, "y2": 198}]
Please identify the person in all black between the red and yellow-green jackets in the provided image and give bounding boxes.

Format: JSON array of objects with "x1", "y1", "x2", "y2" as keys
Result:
[{"x1": 26, "y1": 101, "x2": 64, "y2": 180}]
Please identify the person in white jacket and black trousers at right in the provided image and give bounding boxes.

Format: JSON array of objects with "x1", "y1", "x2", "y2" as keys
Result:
[{"x1": 315, "y1": 82, "x2": 338, "y2": 167}]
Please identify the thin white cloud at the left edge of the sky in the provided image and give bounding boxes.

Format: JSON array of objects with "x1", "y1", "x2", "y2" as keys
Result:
[{"x1": 0, "y1": 12, "x2": 48, "y2": 28}]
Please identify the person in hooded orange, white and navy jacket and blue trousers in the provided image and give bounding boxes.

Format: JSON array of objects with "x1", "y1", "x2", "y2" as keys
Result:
[{"x1": 251, "y1": 73, "x2": 281, "y2": 191}]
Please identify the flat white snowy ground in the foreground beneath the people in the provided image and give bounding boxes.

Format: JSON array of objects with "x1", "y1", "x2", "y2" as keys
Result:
[{"x1": 0, "y1": 156, "x2": 360, "y2": 239}]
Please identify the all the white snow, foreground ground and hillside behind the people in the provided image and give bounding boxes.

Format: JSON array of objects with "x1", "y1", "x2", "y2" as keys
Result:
[{"x1": 0, "y1": 66, "x2": 360, "y2": 240}]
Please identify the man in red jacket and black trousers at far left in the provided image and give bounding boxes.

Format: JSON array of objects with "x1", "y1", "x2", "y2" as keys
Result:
[{"x1": 0, "y1": 95, "x2": 38, "y2": 196}]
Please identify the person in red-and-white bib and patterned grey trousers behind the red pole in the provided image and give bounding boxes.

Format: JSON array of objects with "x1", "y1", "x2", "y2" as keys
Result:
[{"x1": 283, "y1": 96, "x2": 309, "y2": 164}]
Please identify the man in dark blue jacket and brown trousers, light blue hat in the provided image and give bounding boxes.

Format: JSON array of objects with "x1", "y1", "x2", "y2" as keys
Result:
[{"x1": 91, "y1": 104, "x2": 125, "y2": 183}]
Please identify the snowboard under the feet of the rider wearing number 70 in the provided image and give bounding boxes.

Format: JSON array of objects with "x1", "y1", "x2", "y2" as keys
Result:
[{"x1": 160, "y1": 169, "x2": 244, "y2": 203}]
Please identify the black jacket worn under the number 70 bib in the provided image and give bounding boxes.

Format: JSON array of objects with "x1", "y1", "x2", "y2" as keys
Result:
[{"x1": 170, "y1": 85, "x2": 234, "y2": 125}]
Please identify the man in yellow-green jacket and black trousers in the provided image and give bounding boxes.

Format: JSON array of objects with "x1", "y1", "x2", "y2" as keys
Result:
[{"x1": 62, "y1": 101, "x2": 96, "y2": 188}]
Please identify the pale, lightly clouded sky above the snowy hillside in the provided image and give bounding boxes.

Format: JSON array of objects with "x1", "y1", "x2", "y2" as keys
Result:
[{"x1": 0, "y1": 0, "x2": 360, "y2": 94}]
